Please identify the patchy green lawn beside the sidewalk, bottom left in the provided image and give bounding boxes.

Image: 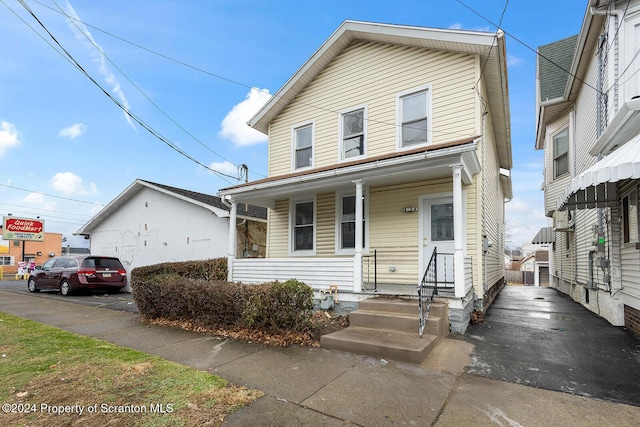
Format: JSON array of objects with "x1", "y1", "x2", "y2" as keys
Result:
[{"x1": 0, "y1": 313, "x2": 262, "y2": 426}]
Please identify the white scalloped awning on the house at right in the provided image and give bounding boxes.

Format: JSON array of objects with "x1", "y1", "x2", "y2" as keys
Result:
[{"x1": 558, "y1": 135, "x2": 640, "y2": 211}]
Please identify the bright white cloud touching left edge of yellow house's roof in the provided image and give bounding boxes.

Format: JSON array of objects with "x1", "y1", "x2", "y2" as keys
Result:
[{"x1": 220, "y1": 88, "x2": 271, "y2": 146}]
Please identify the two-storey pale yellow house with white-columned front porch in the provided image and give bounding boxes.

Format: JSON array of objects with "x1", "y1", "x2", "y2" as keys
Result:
[{"x1": 218, "y1": 21, "x2": 512, "y2": 332}]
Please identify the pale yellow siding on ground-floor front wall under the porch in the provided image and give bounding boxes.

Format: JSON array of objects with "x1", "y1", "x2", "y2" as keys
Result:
[{"x1": 268, "y1": 178, "x2": 482, "y2": 285}]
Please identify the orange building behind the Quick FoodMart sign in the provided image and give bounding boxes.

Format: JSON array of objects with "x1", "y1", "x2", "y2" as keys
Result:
[{"x1": 0, "y1": 232, "x2": 62, "y2": 274}]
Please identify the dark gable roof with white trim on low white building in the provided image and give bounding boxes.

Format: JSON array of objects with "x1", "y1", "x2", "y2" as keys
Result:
[{"x1": 74, "y1": 179, "x2": 267, "y2": 235}]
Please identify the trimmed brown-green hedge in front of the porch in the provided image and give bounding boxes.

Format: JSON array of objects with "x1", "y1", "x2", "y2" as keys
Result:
[{"x1": 131, "y1": 259, "x2": 314, "y2": 332}]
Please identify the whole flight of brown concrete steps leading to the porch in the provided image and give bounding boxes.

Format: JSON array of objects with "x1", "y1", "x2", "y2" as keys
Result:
[{"x1": 320, "y1": 297, "x2": 449, "y2": 365}]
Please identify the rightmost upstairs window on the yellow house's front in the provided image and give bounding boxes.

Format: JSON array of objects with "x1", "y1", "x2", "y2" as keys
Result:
[{"x1": 398, "y1": 86, "x2": 431, "y2": 148}]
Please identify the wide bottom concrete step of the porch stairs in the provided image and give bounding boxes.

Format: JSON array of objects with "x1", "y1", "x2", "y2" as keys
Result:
[{"x1": 320, "y1": 326, "x2": 440, "y2": 364}]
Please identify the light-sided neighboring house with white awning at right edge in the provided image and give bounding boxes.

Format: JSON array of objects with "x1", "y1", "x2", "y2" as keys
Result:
[{"x1": 536, "y1": 0, "x2": 640, "y2": 334}]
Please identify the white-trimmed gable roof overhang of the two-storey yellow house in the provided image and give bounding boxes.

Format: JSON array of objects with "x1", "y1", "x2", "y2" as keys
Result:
[{"x1": 249, "y1": 21, "x2": 512, "y2": 169}]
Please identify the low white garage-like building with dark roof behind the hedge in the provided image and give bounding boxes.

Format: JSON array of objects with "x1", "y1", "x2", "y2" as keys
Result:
[{"x1": 76, "y1": 179, "x2": 266, "y2": 292}]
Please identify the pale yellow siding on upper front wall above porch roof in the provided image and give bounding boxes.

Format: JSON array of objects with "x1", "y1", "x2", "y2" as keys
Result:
[{"x1": 269, "y1": 42, "x2": 476, "y2": 176}]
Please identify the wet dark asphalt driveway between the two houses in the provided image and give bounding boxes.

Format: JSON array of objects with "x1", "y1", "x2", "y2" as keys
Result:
[{"x1": 462, "y1": 286, "x2": 640, "y2": 406}]
